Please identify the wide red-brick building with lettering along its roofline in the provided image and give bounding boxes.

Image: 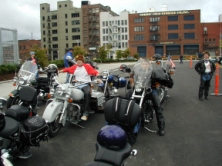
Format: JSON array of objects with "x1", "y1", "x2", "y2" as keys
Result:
[{"x1": 129, "y1": 10, "x2": 203, "y2": 57}]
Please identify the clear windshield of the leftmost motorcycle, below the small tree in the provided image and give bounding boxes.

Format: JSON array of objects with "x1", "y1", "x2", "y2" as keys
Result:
[{"x1": 18, "y1": 61, "x2": 38, "y2": 81}]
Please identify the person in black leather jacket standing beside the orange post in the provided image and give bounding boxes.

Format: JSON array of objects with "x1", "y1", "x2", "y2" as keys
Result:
[{"x1": 195, "y1": 52, "x2": 216, "y2": 101}]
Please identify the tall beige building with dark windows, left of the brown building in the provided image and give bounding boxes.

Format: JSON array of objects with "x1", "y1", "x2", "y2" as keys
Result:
[{"x1": 40, "y1": 1, "x2": 82, "y2": 60}]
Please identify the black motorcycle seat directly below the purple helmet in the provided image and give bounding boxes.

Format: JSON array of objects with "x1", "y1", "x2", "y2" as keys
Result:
[{"x1": 94, "y1": 142, "x2": 132, "y2": 165}]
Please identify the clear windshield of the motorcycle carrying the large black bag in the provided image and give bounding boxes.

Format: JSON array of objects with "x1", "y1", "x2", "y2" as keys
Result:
[{"x1": 133, "y1": 59, "x2": 153, "y2": 88}]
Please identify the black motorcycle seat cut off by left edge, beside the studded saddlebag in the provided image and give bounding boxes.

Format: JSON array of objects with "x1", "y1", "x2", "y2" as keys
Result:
[{"x1": 0, "y1": 116, "x2": 19, "y2": 139}]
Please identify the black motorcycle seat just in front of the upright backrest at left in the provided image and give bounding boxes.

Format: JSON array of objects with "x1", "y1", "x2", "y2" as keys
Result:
[{"x1": 5, "y1": 105, "x2": 30, "y2": 122}]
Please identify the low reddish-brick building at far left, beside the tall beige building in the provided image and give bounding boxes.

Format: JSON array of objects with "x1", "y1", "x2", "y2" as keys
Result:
[{"x1": 18, "y1": 39, "x2": 41, "y2": 61}]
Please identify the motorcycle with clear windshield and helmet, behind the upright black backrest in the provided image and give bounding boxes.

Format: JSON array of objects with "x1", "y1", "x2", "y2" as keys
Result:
[{"x1": 7, "y1": 61, "x2": 58, "y2": 108}]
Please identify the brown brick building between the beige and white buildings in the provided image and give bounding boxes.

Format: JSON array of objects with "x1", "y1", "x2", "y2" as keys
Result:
[{"x1": 81, "y1": 1, "x2": 118, "y2": 57}]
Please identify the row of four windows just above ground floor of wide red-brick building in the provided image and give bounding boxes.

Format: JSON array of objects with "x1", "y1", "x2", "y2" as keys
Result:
[{"x1": 134, "y1": 33, "x2": 195, "y2": 41}]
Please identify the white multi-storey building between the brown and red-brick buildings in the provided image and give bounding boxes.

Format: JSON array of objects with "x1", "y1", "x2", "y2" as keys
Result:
[{"x1": 100, "y1": 10, "x2": 129, "y2": 59}]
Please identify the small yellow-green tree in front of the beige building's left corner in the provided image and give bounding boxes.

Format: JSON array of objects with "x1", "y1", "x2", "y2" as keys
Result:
[{"x1": 27, "y1": 45, "x2": 49, "y2": 68}]
